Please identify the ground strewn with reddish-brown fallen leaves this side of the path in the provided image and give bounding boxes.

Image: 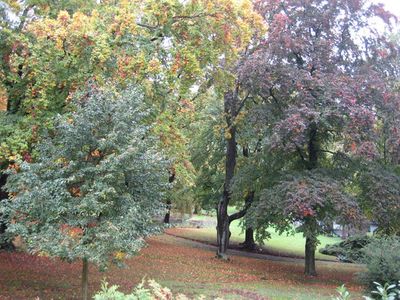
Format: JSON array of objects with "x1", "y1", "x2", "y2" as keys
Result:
[{"x1": 0, "y1": 235, "x2": 362, "y2": 299}]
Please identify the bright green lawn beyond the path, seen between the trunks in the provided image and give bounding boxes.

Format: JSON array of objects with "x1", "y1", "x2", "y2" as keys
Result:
[{"x1": 173, "y1": 212, "x2": 341, "y2": 260}]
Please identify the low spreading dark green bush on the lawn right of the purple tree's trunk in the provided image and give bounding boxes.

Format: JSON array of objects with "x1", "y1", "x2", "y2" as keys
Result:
[{"x1": 319, "y1": 235, "x2": 372, "y2": 263}]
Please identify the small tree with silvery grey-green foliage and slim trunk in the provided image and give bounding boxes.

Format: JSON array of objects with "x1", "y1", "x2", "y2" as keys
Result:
[{"x1": 1, "y1": 87, "x2": 168, "y2": 299}]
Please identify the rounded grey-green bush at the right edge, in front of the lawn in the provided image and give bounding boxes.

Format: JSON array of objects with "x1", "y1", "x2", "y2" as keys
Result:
[{"x1": 360, "y1": 237, "x2": 400, "y2": 289}]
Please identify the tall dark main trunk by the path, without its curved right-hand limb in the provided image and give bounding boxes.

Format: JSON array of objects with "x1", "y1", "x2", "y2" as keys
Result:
[{"x1": 217, "y1": 92, "x2": 237, "y2": 259}]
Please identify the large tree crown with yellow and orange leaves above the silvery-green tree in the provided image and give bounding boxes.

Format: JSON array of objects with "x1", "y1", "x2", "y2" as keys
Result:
[{"x1": 0, "y1": 0, "x2": 266, "y2": 232}]
